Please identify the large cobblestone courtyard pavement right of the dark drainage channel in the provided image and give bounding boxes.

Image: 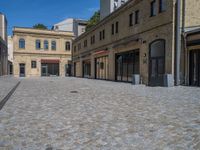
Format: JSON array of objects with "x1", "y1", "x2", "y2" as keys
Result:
[{"x1": 0, "y1": 78, "x2": 200, "y2": 150}]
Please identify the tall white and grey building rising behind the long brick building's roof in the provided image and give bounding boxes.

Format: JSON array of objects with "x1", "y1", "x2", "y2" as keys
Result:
[{"x1": 100, "y1": 0, "x2": 128, "y2": 20}]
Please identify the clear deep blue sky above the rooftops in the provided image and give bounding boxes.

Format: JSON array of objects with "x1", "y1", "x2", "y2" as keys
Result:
[{"x1": 0, "y1": 0, "x2": 99, "y2": 35}]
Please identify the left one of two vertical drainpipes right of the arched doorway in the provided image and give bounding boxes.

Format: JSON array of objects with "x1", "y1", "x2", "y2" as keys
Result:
[{"x1": 175, "y1": 0, "x2": 181, "y2": 86}]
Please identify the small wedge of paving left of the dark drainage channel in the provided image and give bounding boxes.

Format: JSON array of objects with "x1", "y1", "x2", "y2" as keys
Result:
[{"x1": 0, "y1": 76, "x2": 19, "y2": 101}]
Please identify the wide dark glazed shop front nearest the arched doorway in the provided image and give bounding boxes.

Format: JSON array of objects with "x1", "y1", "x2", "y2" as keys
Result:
[{"x1": 115, "y1": 50, "x2": 140, "y2": 82}]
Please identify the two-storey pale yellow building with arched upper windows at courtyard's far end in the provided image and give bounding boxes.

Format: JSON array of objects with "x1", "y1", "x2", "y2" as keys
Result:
[{"x1": 13, "y1": 27, "x2": 74, "y2": 77}]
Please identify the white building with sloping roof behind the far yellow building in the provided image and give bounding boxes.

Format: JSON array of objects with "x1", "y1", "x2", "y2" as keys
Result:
[{"x1": 53, "y1": 18, "x2": 87, "y2": 37}]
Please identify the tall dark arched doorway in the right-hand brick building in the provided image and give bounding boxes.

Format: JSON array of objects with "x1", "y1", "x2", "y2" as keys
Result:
[{"x1": 149, "y1": 39, "x2": 165, "y2": 86}]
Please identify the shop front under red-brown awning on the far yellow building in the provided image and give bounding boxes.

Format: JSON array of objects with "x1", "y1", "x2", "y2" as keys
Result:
[{"x1": 41, "y1": 59, "x2": 60, "y2": 76}]
